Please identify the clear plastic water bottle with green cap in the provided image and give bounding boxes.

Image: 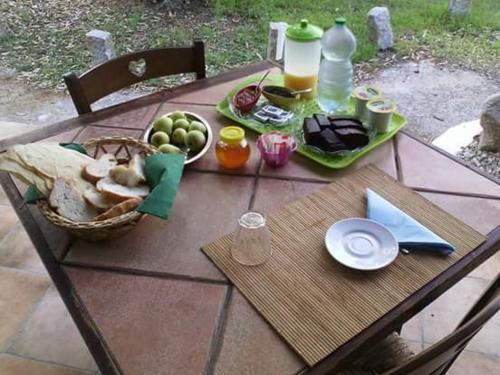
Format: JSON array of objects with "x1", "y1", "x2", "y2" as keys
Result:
[{"x1": 318, "y1": 18, "x2": 356, "y2": 113}]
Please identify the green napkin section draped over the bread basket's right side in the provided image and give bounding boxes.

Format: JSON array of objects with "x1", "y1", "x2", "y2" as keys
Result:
[{"x1": 137, "y1": 154, "x2": 185, "y2": 219}]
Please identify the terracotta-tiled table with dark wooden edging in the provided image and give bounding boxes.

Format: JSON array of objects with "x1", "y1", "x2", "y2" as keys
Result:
[{"x1": 0, "y1": 62, "x2": 500, "y2": 375}]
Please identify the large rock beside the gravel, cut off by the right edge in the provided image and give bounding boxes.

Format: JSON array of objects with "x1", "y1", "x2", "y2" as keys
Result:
[{"x1": 479, "y1": 94, "x2": 500, "y2": 152}]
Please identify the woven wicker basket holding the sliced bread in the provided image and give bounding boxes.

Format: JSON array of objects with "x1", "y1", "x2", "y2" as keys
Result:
[{"x1": 38, "y1": 137, "x2": 158, "y2": 241}]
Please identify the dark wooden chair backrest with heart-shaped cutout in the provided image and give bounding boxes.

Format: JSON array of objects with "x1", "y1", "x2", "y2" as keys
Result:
[{"x1": 64, "y1": 40, "x2": 206, "y2": 115}]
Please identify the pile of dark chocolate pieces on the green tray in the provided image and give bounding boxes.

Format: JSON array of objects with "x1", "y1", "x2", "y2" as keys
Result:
[{"x1": 303, "y1": 113, "x2": 370, "y2": 152}]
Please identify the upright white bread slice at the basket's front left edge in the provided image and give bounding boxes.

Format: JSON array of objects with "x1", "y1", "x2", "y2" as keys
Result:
[{"x1": 49, "y1": 178, "x2": 97, "y2": 222}]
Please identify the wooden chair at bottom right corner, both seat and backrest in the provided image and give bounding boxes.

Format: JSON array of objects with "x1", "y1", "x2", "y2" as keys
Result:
[{"x1": 337, "y1": 275, "x2": 500, "y2": 375}]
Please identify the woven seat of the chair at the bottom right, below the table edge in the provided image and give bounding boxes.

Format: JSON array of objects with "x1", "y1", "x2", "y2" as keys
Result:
[{"x1": 331, "y1": 333, "x2": 415, "y2": 375}]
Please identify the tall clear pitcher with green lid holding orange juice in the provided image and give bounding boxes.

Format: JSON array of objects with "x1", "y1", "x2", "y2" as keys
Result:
[{"x1": 284, "y1": 20, "x2": 323, "y2": 99}]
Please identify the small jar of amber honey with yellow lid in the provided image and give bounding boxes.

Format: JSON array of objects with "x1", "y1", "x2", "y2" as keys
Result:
[{"x1": 215, "y1": 126, "x2": 250, "y2": 169}]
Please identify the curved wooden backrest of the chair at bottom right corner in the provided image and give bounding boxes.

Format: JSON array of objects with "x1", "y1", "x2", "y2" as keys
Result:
[{"x1": 385, "y1": 275, "x2": 500, "y2": 375}]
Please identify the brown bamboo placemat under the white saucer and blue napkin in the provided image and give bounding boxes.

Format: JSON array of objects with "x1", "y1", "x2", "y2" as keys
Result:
[{"x1": 203, "y1": 166, "x2": 485, "y2": 366}]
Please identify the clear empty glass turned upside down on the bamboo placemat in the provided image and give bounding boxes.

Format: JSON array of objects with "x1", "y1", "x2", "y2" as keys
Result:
[{"x1": 231, "y1": 211, "x2": 272, "y2": 266}]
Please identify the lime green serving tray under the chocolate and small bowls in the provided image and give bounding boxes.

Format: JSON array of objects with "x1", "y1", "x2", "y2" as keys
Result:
[{"x1": 217, "y1": 74, "x2": 406, "y2": 169}]
